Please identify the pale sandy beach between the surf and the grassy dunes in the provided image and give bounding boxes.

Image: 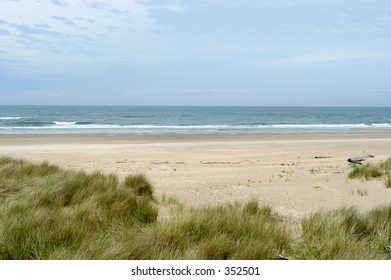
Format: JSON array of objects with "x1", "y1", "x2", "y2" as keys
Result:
[{"x1": 0, "y1": 133, "x2": 391, "y2": 217}]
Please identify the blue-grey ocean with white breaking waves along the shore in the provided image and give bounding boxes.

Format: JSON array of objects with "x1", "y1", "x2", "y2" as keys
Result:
[{"x1": 0, "y1": 106, "x2": 391, "y2": 134}]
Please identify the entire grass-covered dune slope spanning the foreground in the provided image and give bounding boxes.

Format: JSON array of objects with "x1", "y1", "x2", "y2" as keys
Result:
[{"x1": 0, "y1": 157, "x2": 391, "y2": 259}]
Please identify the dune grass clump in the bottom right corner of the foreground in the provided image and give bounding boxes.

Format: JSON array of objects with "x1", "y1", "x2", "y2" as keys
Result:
[{"x1": 289, "y1": 205, "x2": 391, "y2": 260}]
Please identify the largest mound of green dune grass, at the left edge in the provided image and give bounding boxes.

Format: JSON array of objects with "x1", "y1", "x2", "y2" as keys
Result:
[{"x1": 0, "y1": 158, "x2": 158, "y2": 259}]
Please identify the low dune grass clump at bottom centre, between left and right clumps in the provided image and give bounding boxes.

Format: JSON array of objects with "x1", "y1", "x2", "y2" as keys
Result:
[{"x1": 86, "y1": 202, "x2": 290, "y2": 260}]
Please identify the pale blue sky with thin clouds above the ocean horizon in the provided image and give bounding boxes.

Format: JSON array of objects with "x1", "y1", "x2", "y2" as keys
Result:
[{"x1": 0, "y1": 0, "x2": 391, "y2": 106}]
